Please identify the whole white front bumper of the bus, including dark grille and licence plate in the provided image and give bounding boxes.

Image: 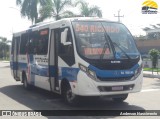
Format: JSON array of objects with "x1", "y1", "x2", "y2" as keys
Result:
[{"x1": 71, "y1": 73, "x2": 143, "y2": 96}]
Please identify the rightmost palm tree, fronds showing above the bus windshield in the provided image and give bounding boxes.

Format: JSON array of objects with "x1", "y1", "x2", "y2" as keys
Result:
[{"x1": 75, "y1": 0, "x2": 102, "y2": 17}]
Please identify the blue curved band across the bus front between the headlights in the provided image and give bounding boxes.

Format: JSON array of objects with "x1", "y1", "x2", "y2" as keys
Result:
[{"x1": 88, "y1": 64, "x2": 139, "y2": 78}]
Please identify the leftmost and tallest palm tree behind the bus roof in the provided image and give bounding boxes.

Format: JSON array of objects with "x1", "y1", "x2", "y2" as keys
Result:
[{"x1": 16, "y1": 0, "x2": 51, "y2": 24}]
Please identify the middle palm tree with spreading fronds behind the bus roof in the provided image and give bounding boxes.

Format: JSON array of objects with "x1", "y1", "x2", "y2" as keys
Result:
[{"x1": 40, "y1": 0, "x2": 74, "y2": 20}]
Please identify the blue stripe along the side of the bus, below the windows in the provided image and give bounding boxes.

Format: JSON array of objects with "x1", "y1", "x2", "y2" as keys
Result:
[{"x1": 11, "y1": 62, "x2": 79, "y2": 81}]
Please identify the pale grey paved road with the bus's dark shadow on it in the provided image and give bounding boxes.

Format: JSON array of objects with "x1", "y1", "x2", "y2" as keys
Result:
[{"x1": 0, "y1": 62, "x2": 160, "y2": 119}]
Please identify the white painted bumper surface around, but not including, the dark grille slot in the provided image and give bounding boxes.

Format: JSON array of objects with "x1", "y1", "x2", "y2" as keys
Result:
[{"x1": 72, "y1": 72, "x2": 143, "y2": 96}]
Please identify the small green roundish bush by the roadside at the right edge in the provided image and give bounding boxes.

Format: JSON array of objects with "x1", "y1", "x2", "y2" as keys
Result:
[{"x1": 149, "y1": 49, "x2": 159, "y2": 68}]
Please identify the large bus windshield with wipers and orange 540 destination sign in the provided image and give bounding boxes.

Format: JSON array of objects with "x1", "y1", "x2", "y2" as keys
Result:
[{"x1": 73, "y1": 21, "x2": 139, "y2": 59}]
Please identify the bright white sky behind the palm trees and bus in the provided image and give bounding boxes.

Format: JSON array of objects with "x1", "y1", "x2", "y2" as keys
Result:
[{"x1": 0, "y1": 0, "x2": 160, "y2": 40}]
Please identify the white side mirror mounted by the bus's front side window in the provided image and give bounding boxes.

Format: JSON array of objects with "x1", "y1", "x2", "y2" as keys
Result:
[{"x1": 61, "y1": 28, "x2": 72, "y2": 45}]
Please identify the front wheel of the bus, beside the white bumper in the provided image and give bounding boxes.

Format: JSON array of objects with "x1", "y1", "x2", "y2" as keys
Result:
[{"x1": 63, "y1": 84, "x2": 79, "y2": 106}]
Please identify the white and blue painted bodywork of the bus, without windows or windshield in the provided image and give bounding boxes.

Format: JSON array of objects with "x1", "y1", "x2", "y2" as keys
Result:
[{"x1": 11, "y1": 19, "x2": 143, "y2": 96}]
